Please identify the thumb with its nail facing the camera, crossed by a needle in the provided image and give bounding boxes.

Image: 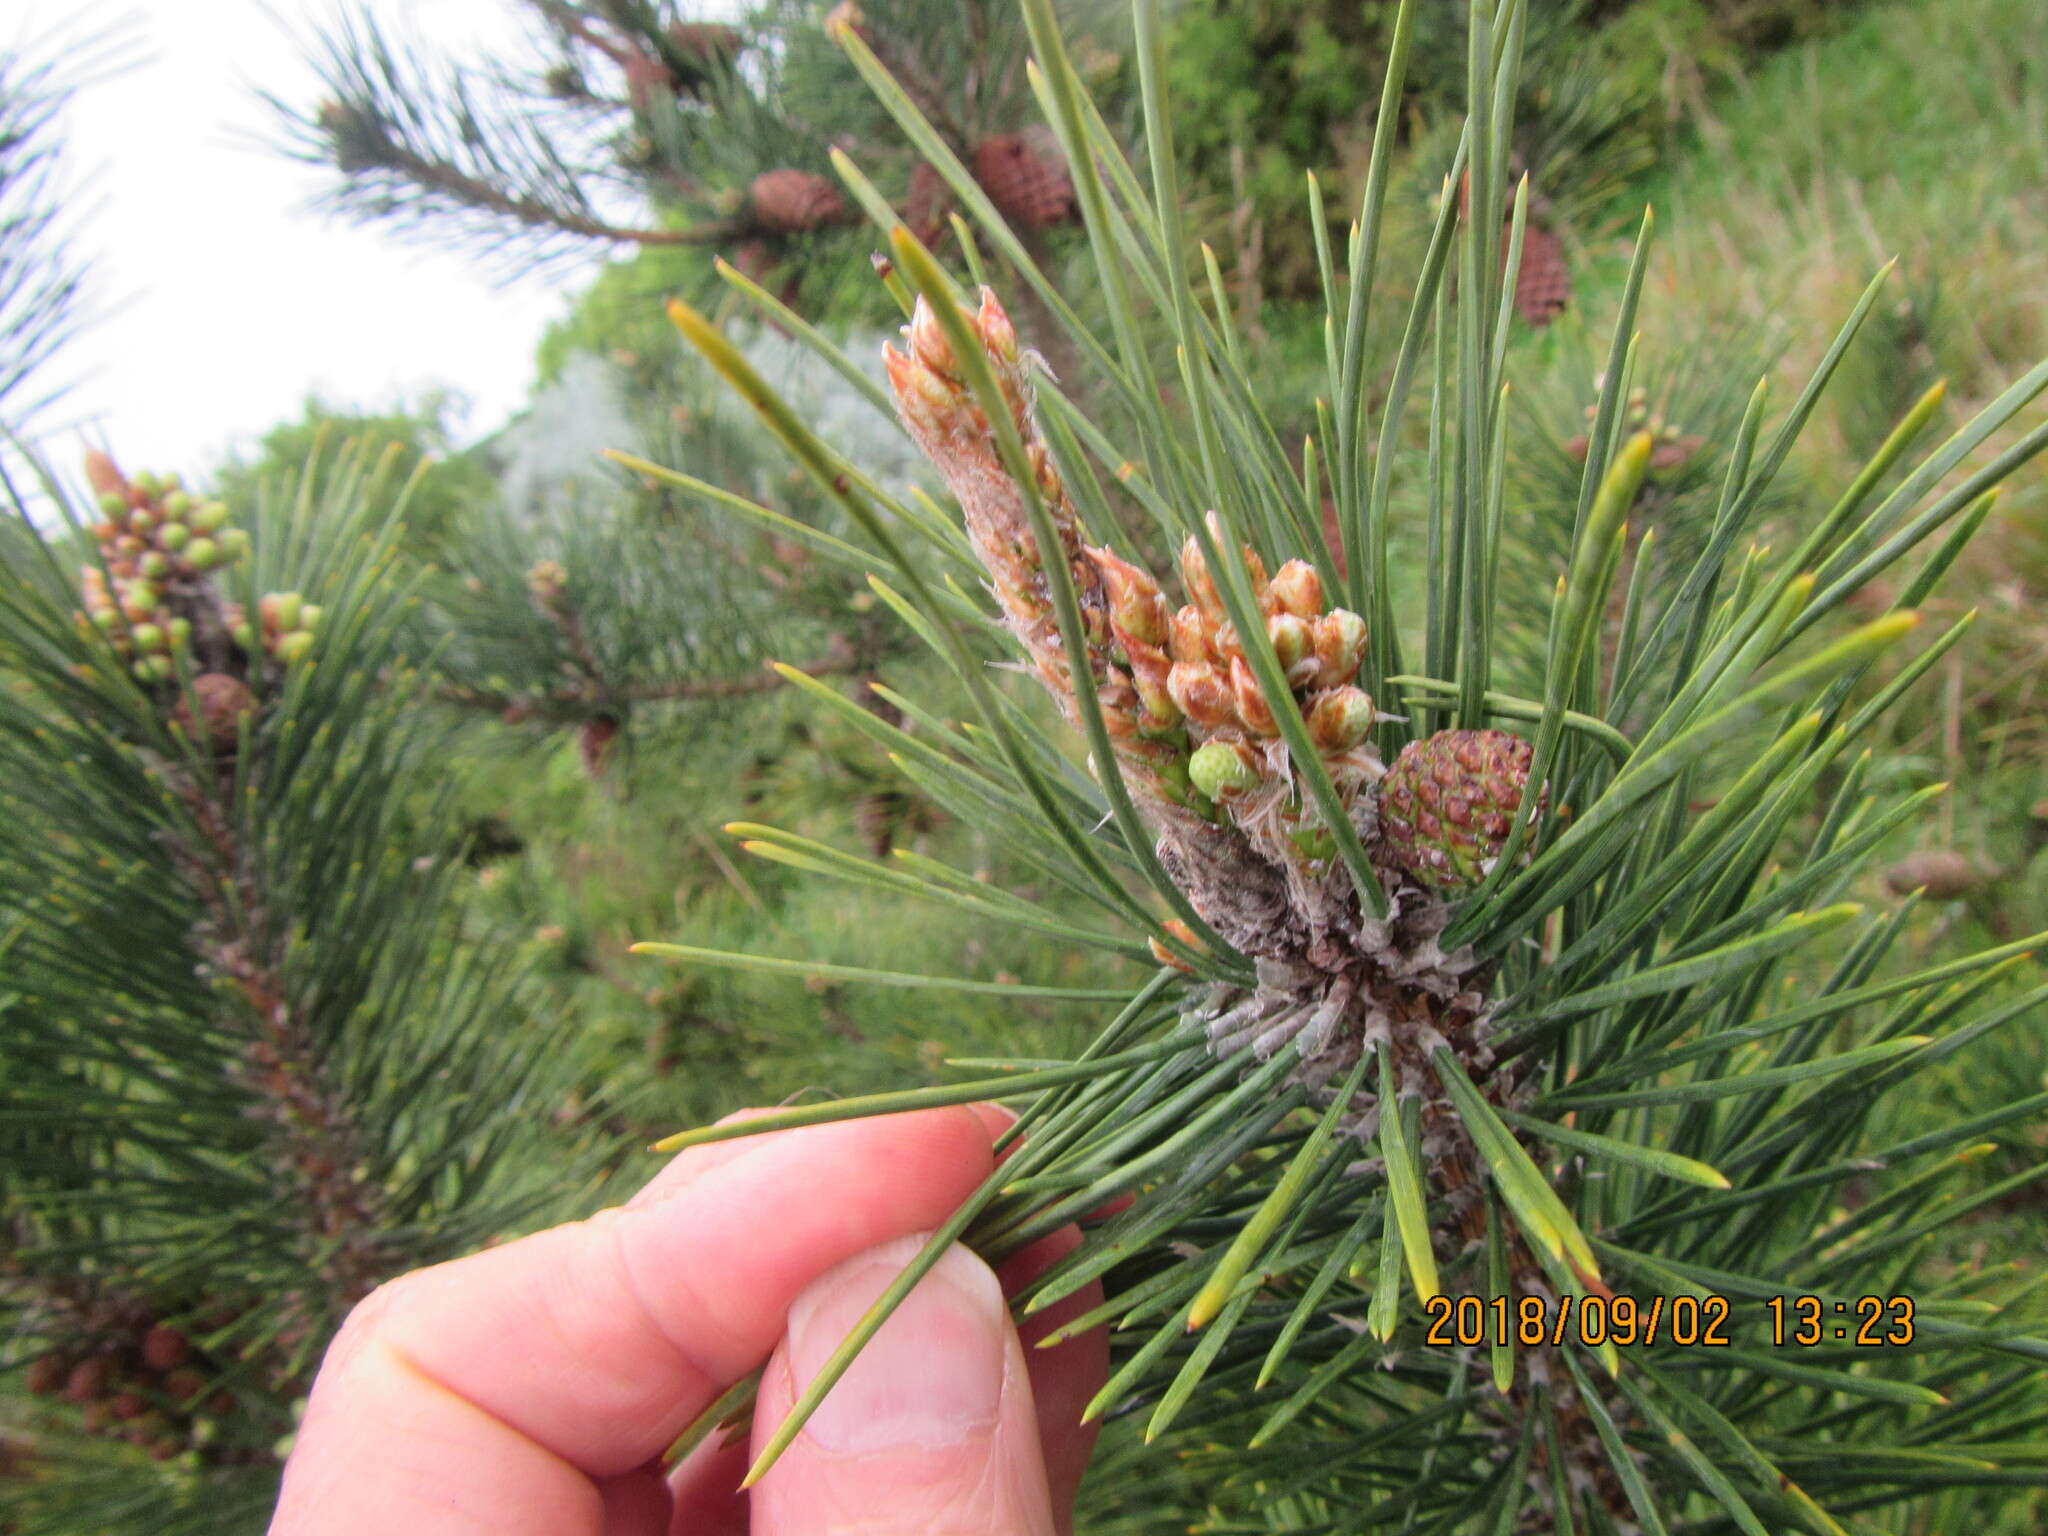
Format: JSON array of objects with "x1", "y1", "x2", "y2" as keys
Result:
[{"x1": 754, "y1": 1235, "x2": 1055, "y2": 1536}]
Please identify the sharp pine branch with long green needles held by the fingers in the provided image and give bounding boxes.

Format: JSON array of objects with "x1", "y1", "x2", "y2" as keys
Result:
[{"x1": 645, "y1": 0, "x2": 2048, "y2": 1536}]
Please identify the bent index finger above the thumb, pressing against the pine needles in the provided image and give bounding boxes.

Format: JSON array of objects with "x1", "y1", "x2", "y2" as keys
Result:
[{"x1": 272, "y1": 1108, "x2": 991, "y2": 1536}]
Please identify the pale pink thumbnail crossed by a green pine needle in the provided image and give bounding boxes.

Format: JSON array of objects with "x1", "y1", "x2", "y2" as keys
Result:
[{"x1": 788, "y1": 1235, "x2": 1010, "y2": 1454}]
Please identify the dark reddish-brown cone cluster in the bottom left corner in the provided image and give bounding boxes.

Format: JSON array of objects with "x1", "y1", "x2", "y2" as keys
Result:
[{"x1": 27, "y1": 1307, "x2": 236, "y2": 1460}]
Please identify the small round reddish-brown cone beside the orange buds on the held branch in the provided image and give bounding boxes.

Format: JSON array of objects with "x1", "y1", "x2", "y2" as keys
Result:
[{"x1": 1380, "y1": 731, "x2": 1534, "y2": 891}]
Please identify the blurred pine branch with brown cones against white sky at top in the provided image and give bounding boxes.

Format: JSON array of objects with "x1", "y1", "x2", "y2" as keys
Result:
[{"x1": 276, "y1": 0, "x2": 1105, "y2": 299}]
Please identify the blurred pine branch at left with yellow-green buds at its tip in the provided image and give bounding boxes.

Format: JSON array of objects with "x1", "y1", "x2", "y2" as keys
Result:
[{"x1": 0, "y1": 442, "x2": 596, "y2": 1534}]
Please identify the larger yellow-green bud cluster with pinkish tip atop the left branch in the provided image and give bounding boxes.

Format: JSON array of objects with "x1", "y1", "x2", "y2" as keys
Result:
[{"x1": 78, "y1": 453, "x2": 250, "y2": 682}]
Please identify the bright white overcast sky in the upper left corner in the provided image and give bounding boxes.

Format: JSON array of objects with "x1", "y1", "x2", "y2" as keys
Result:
[{"x1": 19, "y1": 0, "x2": 586, "y2": 473}]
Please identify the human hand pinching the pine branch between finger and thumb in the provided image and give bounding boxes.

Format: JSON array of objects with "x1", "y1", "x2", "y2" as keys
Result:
[{"x1": 270, "y1": 1106, "x2": 1108, "y2": 1536}]
